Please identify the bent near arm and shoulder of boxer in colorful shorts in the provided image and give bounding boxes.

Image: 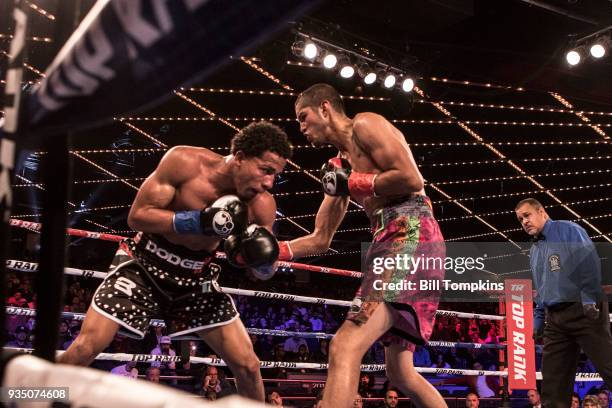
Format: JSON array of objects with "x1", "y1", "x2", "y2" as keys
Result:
[{"x1": 353, "y1": 112, "x2": 424, "y2": 196}]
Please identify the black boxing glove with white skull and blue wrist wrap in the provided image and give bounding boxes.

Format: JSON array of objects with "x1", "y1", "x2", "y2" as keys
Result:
[{"x1": 172, "y1": 195, "x2": 248, "y2": 238}]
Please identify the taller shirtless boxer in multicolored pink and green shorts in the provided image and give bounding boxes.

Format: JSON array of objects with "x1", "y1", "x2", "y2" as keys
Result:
[{"x1": 279, "y1": 84, "x2": 446, "y2": 408}]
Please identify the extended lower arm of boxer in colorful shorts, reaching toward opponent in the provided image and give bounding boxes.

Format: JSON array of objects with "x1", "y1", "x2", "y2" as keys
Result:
[{"x1": 289, "y1": 195, "x2": 349, "y2": 259}]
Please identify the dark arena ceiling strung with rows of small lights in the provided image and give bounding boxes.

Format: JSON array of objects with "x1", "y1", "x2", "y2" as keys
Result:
[{"x1": 2, "y1": 0, "x2": 612, "y2": 269}]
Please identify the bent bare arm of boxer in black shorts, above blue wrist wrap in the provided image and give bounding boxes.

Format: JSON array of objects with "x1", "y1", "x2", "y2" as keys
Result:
[{"x1": 128, "y1": 147, "x2": 195, "y2": 234}]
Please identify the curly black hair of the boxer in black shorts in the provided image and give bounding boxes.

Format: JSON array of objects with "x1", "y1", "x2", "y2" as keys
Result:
[{"x1": 231, "y1": 121, "x2": 293, "y2": 159}]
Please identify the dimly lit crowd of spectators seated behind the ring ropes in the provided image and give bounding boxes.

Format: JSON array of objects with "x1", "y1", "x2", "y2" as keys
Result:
[{"x1": 5, "y1": 274, "x2": 607, "y2": 408}]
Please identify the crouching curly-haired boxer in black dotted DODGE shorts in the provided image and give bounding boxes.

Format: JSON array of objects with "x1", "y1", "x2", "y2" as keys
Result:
[{"x1": 58, "y1": 122, "x2": 292, "y2": 401}]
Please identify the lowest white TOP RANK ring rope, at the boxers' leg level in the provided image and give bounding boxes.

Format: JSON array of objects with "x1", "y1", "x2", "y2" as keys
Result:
[{"x1": 4, "y1": 347, "x2": 603, "y2": 381}]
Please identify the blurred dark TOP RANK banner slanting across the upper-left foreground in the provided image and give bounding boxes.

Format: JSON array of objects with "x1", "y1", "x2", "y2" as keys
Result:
[{"x1": 23, "y1": 0, "x2": 317, "y2": 137}]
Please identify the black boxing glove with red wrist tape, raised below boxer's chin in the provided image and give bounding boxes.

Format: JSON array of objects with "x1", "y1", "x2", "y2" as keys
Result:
[{"x1": 321, "y1": 157, "x2": 377, "y2": 199}]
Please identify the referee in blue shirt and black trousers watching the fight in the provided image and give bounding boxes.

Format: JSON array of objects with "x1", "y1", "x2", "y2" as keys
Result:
[{"x1": 514, "y1": 198, "x2": 612, "y2": 408}]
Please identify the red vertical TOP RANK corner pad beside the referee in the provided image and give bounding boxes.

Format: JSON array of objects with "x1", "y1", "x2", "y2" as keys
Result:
[{"x1": 505, "y1": 279, "x2": 536, "y2": 390}]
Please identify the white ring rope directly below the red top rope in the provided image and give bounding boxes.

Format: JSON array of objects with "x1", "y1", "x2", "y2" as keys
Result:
[{"x1": 6, "y1": 259, "x2": 505, "y2": 320}]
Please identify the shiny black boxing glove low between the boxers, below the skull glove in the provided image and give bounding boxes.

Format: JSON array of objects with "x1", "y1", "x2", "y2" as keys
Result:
[{"x1": 223, "y1": 224, "x2": 279, "y2": 280}]
